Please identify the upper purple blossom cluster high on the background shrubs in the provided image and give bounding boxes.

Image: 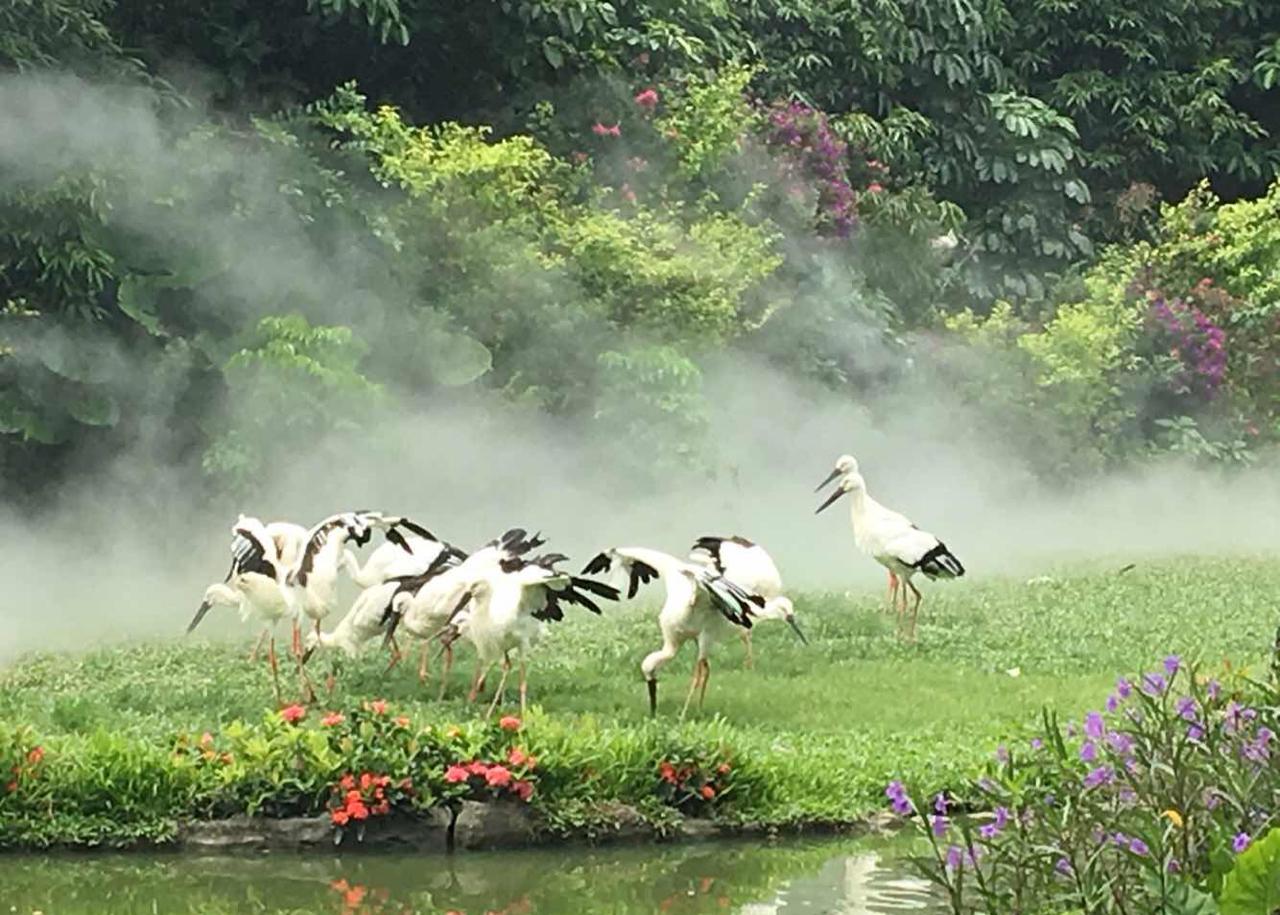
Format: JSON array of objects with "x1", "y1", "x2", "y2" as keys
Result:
[{"x1": 764, "y1": 101, "x2": 858, "y2": 238}]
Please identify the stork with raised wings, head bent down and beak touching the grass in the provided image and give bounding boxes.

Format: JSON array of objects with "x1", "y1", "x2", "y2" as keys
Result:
[{"x1": 582, "y1": 546, "x2": 783, "y2": 717}]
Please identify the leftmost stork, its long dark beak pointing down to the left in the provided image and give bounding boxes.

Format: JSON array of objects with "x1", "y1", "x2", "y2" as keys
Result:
[{"x1": 187, "y1": 514, "x2": 305, "y2": 703}]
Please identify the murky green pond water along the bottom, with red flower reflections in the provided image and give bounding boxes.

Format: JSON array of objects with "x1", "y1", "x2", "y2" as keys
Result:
[{"x1": 0, "y1": 841, "x2": 942, "y2": 915}]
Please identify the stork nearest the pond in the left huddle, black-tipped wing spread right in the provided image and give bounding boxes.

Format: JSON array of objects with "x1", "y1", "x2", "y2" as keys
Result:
[{"x1": 463, "y1": 553, "x2": 618, "y2": 715}]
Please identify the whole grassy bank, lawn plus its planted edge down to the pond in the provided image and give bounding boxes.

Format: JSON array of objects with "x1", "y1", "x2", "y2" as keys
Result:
[{"x1": 0, "y1": 558, "x2": 1280, "y2": 846}]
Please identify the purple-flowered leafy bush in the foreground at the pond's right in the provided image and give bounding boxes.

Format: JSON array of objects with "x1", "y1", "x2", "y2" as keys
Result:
[{"x1": 886, "y1": 656, "x2": 1280, "y2": 915}]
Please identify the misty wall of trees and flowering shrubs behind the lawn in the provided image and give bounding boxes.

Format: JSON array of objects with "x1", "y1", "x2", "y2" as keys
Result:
[{"x1": 0, "y1": 0, "x2": 1280, "y2": 498}]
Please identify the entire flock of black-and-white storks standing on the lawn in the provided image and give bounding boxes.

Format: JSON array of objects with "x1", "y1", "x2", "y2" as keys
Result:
[{"x1": 187, "y1": 454, "x2": 964, "y2": 715}]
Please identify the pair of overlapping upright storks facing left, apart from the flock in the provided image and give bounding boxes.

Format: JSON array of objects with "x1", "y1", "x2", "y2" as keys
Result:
[{"x1": 814, "y1": 454, "x2": 964, "y2": 641}]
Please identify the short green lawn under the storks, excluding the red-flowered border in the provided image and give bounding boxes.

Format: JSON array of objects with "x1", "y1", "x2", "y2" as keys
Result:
[{"x1": 0, "y1": 558, "x2": 1280, "y2": 834}]
